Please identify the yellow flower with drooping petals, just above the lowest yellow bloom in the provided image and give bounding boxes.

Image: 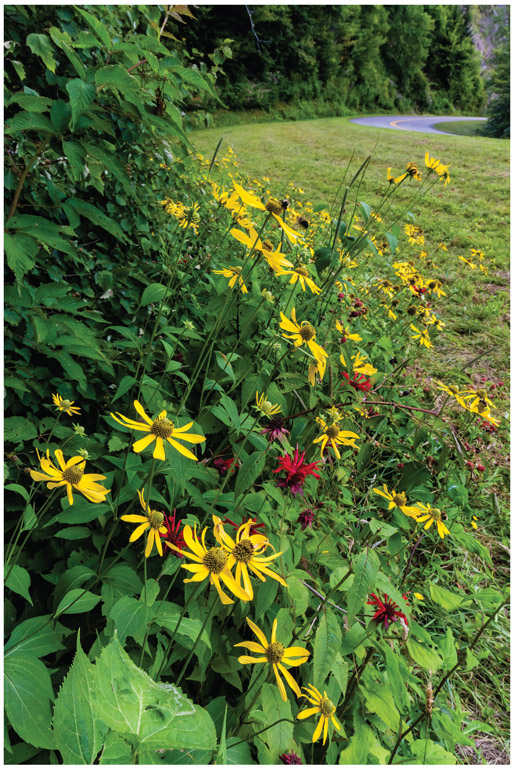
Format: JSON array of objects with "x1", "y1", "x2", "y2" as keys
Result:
[{"x1": 235, "y1": 617, "x2": 310, "y2": 702}]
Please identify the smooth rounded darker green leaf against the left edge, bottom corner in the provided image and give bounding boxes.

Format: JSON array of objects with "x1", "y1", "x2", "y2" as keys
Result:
[{"x1": 4, "y1": 650, "x2": 55, "y2": 749}]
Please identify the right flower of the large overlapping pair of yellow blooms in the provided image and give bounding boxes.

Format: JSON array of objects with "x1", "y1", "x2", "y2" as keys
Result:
[{"x1": 212, "y1": 515, "x2": 287, "y2": 599}]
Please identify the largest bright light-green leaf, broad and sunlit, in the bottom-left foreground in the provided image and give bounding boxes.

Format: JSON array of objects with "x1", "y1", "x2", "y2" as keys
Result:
[{"x1": 95, "y1": 637, "x2": 216, "y2": 752}]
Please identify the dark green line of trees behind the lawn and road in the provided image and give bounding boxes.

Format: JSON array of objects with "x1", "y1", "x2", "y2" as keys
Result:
[{"x1": 182, "y1": 5, "x2": 484, "y2": 116}]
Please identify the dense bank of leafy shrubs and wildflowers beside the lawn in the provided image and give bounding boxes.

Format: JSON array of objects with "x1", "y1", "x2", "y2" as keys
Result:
[{"x1": 4, "y1": 6, "x2": 507, "y2": 764}]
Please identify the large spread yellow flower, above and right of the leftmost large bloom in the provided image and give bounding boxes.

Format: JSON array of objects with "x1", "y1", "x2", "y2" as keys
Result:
[{"x1": 110, "y1": 401, "x2": 205, "y2": 462}]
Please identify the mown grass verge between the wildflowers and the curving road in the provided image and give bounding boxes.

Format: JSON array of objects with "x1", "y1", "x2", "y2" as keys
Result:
[{"x1": 192, "y1": 118, "x2": 509, "y2": 763}]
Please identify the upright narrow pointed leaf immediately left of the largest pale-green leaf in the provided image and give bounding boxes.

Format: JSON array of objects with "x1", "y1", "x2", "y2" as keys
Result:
[{"x1": 53, "y1": 633, "x2": 107, "y2": 764}]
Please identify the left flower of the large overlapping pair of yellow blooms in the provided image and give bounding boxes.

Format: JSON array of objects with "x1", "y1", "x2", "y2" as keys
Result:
[{"x1": 165, "y1": 525, "x2": 250, "y2": 605}]
